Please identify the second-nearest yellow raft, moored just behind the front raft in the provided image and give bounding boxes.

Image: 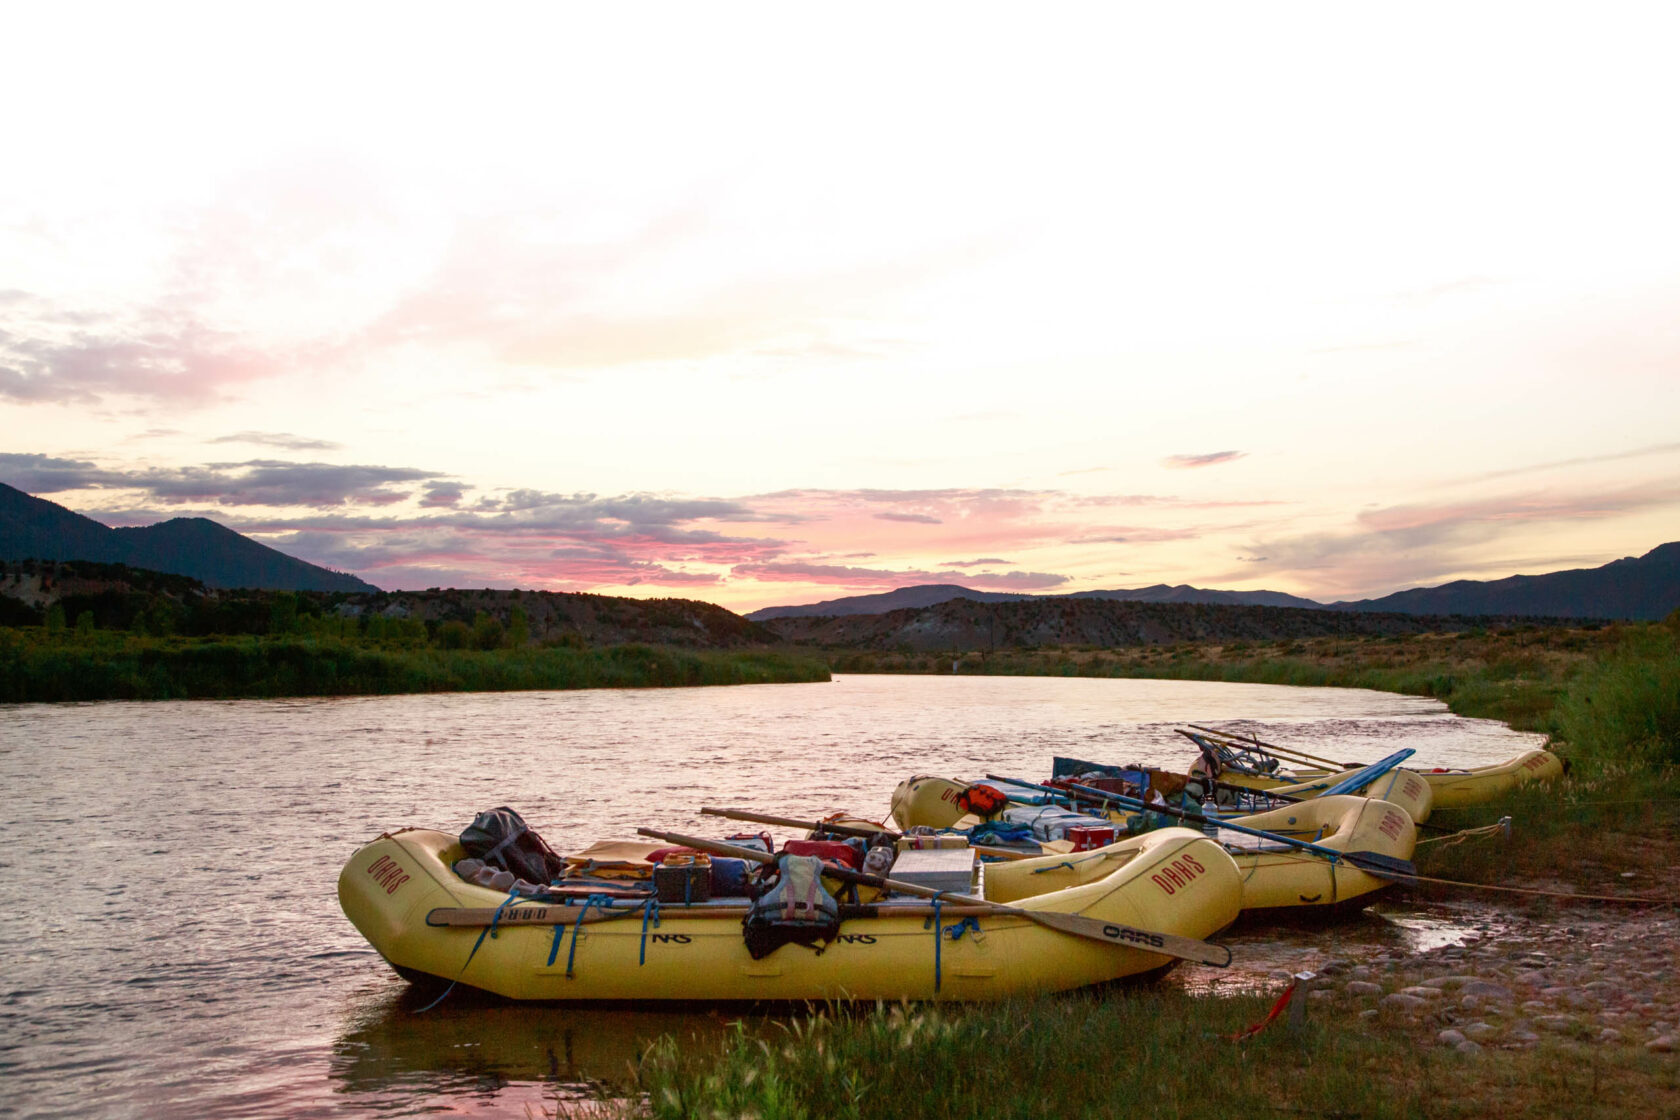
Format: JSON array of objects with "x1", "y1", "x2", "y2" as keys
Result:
[{"x1": 892, "y1": 776, "x2": 1418, "y2": 917}]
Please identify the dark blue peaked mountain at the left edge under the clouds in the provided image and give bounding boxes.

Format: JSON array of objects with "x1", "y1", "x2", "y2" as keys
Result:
[{"x1": 0, "y1": 484, "x2": 378, "y2": 591}]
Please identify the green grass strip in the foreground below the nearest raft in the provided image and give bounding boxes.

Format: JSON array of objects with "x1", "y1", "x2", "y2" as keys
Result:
[{"x1": 554, "y1": 989, "x2": 1680, "y2": 1120}]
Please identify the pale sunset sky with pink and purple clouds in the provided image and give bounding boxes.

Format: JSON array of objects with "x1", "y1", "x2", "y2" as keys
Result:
[{"x1": 0, "y1": 3, "x2": 1680, "y2": 611}]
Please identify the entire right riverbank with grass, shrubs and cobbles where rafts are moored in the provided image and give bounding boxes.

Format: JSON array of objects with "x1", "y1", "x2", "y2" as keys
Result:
[{"x1": 540, "y1": 620, "x2": 1680, "y2": 1120}]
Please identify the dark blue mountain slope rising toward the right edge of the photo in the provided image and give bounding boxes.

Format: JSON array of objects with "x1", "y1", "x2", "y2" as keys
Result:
[{"x1": 1331, "y1": 541, "x2": 1680, "y2": 620}]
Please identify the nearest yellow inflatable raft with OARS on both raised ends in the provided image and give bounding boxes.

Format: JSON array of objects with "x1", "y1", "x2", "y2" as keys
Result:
[{"x1": 338, "y1": 828, "x2": 1242, "y2": 1001}]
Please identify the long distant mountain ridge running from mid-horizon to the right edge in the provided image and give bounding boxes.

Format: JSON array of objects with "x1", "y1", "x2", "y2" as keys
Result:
[{"x1": 746, "y1": 542, "x2": 1680, "y2": 623}]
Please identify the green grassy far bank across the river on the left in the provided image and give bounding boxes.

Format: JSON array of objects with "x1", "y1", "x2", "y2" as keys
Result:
[{"x1": 0, "y1": 630, "x2": 828, "y2": 702}]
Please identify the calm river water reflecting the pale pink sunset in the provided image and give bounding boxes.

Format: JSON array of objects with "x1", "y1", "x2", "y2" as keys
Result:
[{"x1": 0, "y1": 677, "x2": 1536, "y2": 1117}]
